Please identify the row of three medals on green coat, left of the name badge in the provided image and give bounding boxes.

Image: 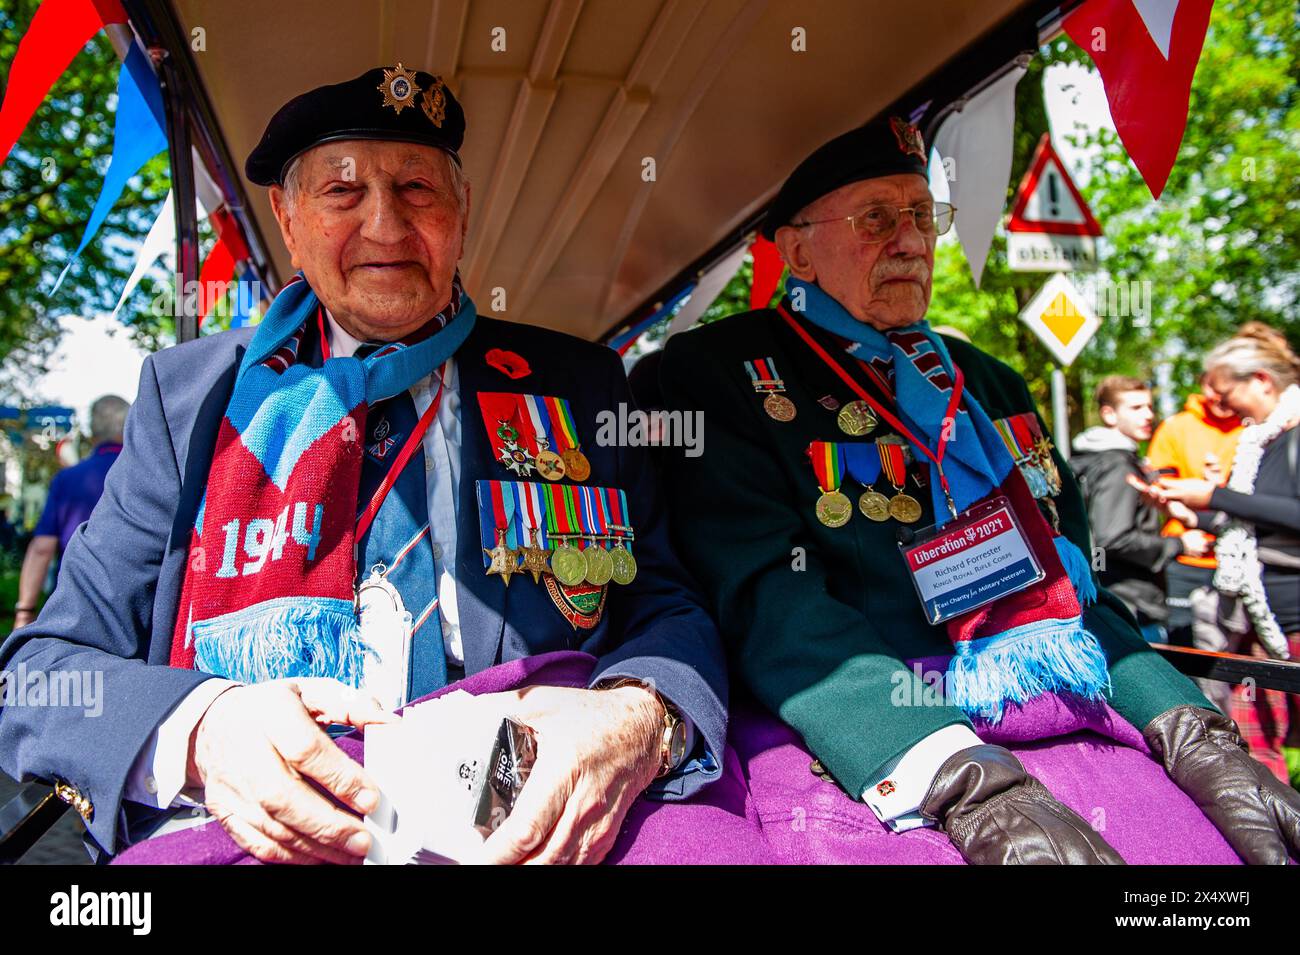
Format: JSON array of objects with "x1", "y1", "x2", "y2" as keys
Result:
[{"x1": 807, "y1": 435, "x2": 922, "y2": 528}]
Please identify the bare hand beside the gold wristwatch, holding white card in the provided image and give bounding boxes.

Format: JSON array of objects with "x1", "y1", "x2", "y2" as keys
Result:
[{"x1": 482, "y1": 686, "x2": 664, "y2": 864}]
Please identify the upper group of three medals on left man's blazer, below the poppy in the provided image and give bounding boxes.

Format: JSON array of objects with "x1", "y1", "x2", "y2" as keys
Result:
[{"x1": 478, "y1": 391, "x2": 592, "y2": 481}]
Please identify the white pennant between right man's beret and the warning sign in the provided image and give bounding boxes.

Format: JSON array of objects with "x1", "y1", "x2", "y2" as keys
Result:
[{"x1": 935, "y1": 66, "x2": 1026, "y2": 288}]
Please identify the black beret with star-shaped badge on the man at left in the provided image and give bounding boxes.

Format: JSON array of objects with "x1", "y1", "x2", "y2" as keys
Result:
[{"x1": 244, "y1": 64, "x2": 465, "y2": 186}]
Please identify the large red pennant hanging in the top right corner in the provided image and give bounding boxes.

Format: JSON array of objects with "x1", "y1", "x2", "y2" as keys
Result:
[{"x1": 1065, "y1": 0, "x2": 1214, "y2": 199}]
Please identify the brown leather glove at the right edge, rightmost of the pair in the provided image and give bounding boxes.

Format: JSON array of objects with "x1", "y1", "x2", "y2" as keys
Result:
[{"x1": 1143, "y1": 706, "x2": 1300, "y2": 865}]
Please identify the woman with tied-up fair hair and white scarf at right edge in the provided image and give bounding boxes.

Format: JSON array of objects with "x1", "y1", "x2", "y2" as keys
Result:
[{"x1": 1148, "y1": 322, "x2": 1300, "y2": 785}]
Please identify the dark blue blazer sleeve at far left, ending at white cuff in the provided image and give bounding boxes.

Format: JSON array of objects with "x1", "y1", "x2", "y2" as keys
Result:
[{"x1": 0, "y1": 357, "x2": 220, "y2": 852}]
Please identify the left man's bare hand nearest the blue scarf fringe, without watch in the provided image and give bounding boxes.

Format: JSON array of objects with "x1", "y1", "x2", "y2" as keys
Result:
[{"x1": 189, "y1": 678, "x2": 399, "y2": 864}]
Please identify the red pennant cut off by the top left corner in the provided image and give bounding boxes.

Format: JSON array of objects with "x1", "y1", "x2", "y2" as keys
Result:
[{"x1": 0, "y1": 0, "x2": 126, "y2": 159}]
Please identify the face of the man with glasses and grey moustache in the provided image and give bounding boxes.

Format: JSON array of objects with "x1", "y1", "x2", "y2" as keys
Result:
[{"x1": 776, "y1": 173, "x2": 935, "y2": 330}]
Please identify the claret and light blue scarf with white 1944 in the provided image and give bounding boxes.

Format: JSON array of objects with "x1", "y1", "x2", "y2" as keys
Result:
[{"x1": 170, "y1": 277, "x2": 476, "y2": 686}]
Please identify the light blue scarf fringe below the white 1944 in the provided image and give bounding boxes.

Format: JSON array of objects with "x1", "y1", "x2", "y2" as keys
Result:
[{"x1": 192, "y1": 598, "x2": 368, "y2": 686}]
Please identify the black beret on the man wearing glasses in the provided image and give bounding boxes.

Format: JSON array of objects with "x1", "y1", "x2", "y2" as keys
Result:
[{"x1": 762, "y1": 116, "x2": 930, "y2": 239}]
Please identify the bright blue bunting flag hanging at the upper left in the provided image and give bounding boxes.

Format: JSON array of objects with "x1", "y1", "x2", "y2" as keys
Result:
[{"x1": 52, "y1": 44, "x2": 166, "y2": 291}]
